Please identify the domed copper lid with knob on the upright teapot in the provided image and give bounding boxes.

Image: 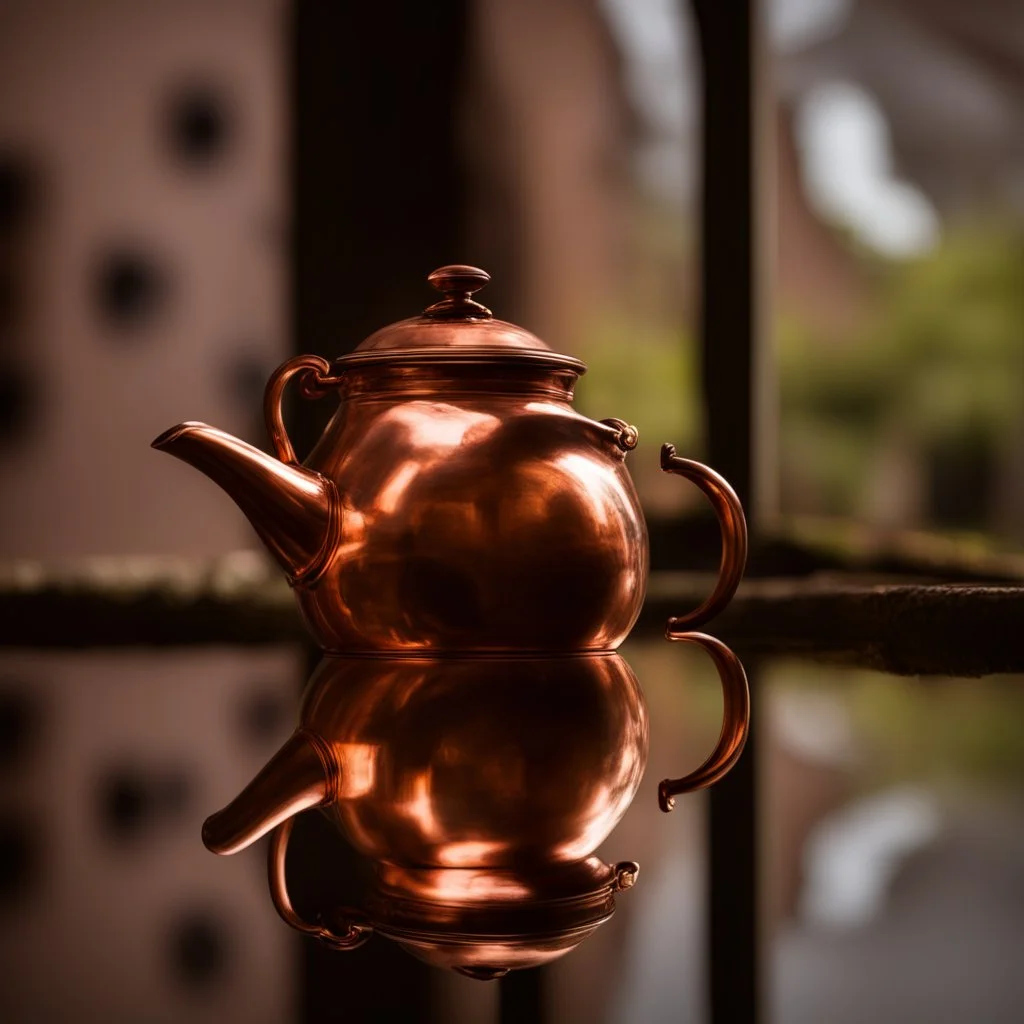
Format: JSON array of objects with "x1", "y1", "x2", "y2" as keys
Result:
[{"x1": 334, "y1": 264, "x2": 587, "y2": 374}]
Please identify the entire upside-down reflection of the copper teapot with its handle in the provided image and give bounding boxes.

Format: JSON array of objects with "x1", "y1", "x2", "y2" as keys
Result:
[{"x1": 203, "y1": 634, "x2": 746, "y2": 978}]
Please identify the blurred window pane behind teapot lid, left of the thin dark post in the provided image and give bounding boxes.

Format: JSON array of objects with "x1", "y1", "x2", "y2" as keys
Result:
[{"x1": 472, "y1": 0, "x2": 700, "y2": 513}]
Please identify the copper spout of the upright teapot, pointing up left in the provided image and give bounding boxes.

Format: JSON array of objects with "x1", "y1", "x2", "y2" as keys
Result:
[{"x1": 153, "y1": 423, "x2": 340, "y2": 584}]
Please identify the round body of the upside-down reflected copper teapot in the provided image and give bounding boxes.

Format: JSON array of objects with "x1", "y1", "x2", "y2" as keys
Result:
[{"x1": 301, "y1": 654, "x2": 647, "y2": 868}]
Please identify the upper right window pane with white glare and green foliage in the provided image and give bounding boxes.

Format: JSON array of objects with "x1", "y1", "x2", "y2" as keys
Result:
[{"x1": 773, "y1": 0, "x2": 1024, "y2": 542}]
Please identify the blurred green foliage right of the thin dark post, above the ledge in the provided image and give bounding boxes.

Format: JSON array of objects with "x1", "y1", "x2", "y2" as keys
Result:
[{"x1": 777, "y1": 223, "x2": 1024, "y2": 516}]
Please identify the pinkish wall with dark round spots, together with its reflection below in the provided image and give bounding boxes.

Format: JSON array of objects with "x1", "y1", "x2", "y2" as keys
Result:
[{"x1": 0, "y1": 0, "x2": 298, "y2": 1024}]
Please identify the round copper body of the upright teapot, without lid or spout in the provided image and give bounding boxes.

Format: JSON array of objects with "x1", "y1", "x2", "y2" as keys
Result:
[{"x1": 296, "y1": 372, "x2": 647, "y2": 653}]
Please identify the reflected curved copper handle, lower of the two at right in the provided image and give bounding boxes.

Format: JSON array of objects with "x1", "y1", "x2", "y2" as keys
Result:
[{"x1": 657, "y1": 632, "x2": 751, "y2": 811}]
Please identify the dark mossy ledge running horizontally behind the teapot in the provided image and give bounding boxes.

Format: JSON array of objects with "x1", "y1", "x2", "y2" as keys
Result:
[{"x1": 0, "y1": 552, "x2": 1024, "y2": 676}]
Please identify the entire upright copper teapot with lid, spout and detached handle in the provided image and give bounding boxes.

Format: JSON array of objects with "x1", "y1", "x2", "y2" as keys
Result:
[{"x1": 154, "y1": 267, "x2": 745, "y2": 653}]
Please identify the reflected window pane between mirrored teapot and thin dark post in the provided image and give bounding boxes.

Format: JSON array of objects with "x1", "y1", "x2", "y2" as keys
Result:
[{"x1": 548, "y1": 640, "x2": 722, "y2": 1024}]
